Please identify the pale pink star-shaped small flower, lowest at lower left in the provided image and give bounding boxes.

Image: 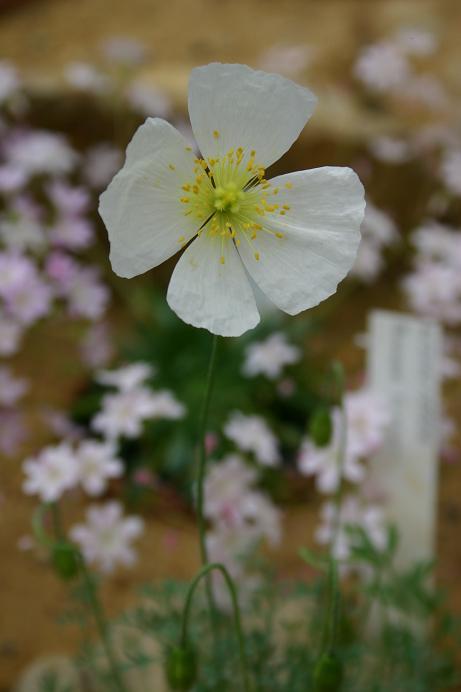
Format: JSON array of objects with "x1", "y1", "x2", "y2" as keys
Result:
[{"x1": 70, "y1": 502, "x2": 144, "y2": 574}]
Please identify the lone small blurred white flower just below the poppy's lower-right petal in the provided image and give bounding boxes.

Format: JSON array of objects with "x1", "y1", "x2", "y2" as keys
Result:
[{"x1": 243, "y1": 332, "x2": 301, "y2": 380}]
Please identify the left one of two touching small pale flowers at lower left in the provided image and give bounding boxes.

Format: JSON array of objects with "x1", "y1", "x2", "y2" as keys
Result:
[{"x1": 23, "y1": 443, "x2": 78, "y2": 502}]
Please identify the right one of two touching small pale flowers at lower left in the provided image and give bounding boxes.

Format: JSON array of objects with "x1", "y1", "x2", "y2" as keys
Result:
[{"x1": 76, "y1": 440, "x2": 123, "y2": 496}]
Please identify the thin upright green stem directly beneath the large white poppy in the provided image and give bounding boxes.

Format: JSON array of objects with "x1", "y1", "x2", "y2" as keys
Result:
[{"x1": 197, "y1": 334, "x2": 218, "y2": 567}]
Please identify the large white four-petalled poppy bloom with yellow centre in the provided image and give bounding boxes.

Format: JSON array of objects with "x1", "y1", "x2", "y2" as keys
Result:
[{"x1": 99, "y1": 63, "x2": 365, "y2": 336}]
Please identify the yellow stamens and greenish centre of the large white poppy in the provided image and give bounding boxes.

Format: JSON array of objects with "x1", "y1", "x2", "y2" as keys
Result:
[{"x1": 169, "y1": 138, "x2": 292, "y2": 264}]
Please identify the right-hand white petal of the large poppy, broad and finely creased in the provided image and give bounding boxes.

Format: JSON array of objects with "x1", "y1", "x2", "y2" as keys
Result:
[{"x1": 239, "y1": 167, "x2": 365, "y2": 315}]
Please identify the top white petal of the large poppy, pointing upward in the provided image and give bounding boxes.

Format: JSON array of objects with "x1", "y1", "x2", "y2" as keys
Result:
[{"x1": 189, "y1": 63, "x2": 316, "y2": 167}]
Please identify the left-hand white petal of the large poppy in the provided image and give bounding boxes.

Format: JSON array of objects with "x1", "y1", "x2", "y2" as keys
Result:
[{"x1": 99, "y1": 118, "x2": 201, "y2": 278}]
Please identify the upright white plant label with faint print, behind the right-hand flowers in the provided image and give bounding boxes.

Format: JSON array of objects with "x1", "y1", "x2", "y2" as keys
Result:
[{"x1": 367, "y1": 310, "x2": 442, "y2": 567}]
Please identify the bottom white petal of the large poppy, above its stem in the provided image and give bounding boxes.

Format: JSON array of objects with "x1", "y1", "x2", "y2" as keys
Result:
[{"x1": 167, "y1": 233, "x2": 259, "y2": 336}]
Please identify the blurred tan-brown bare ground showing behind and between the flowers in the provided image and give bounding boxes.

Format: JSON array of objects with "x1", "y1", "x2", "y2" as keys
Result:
[{"x1": 0, "y1": 0, "x2": 461, "y2": 692}]
